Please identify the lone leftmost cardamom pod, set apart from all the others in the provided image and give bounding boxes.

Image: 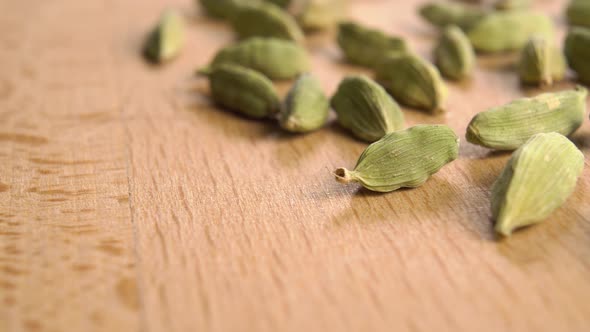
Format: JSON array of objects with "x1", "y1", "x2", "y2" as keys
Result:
[{"x1": 143, "y1": 9, "x2": 184, "y2": 62}]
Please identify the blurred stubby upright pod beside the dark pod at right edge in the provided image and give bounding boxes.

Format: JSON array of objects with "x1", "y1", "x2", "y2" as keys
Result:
[{"x1": 518, "y1": 37, "x2": 567, "y2": 85}]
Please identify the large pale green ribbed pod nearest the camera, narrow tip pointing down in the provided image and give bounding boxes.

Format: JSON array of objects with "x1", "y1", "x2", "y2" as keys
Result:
[{"x1": 492, "y1": 133, "x2": 584, "y2": 236}]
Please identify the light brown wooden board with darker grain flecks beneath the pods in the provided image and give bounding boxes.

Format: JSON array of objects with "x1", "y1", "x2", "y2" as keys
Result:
[{"x1": 0, "y1": 0, "x2": 590, "y2": 332}]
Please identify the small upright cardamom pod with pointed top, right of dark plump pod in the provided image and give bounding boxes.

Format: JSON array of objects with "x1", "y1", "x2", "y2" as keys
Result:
[{"x1": 279, "y1": 74, "x2": 330, "y2": 133}]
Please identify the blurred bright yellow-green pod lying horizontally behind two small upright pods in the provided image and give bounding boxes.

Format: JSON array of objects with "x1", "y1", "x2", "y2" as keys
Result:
[{"x1": 467, "y1": 10, "x2": 553, "y2": 52}]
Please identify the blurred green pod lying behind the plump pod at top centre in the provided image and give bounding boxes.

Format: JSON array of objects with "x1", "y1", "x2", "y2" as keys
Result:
[{"x1": 338, "y1": 22, "x2": 408, "y2": 68}]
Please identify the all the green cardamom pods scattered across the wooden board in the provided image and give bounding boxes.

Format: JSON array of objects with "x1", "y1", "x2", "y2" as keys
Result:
[{"x1": 144, "y1": 0, "x2": 590, "y2": 235}]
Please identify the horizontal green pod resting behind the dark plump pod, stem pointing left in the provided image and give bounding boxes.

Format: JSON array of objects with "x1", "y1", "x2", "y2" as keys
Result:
[{"x1": 211, "y1": 37, "x2": 310, "y2": 79}]
